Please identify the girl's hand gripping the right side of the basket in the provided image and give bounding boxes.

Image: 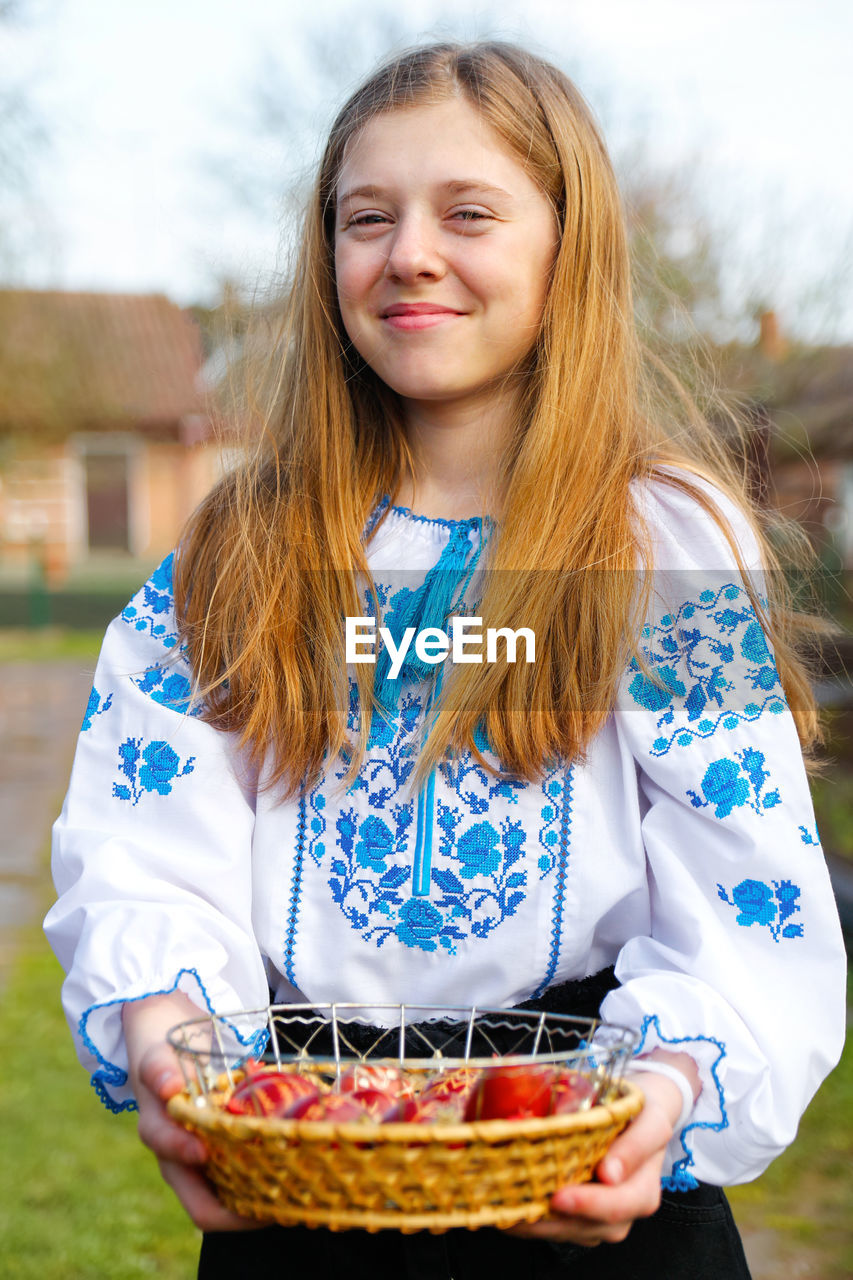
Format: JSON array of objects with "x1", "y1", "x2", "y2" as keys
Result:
[{"x1": 510, "y1": 1053, "x2": 698, "y2": 1247}]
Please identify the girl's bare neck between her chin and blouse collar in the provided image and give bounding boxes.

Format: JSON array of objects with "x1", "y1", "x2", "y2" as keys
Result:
[{"x1": 394, "y1": 402, "x2": 510, "y2": 520}]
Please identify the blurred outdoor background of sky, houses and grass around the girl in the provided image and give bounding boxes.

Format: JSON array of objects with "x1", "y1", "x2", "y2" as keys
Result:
[{"x1": 0, "y1": 0, "x2": 853, "y2": 1280}]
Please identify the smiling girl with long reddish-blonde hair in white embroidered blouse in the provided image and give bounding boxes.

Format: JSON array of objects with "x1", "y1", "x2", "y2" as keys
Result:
[{"x1": 46, "y1": 44, "x2": 844, "y2": 1280}]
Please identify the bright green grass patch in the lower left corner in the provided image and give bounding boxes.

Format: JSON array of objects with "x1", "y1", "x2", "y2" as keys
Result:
[{"x1": 0, "y1": 929, "x2": 200, "y2": 1280}]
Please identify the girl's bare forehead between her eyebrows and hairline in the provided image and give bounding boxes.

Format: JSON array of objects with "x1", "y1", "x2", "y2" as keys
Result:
[{"x1": 337, "y1": 97, "x2": 539, "y2": 198}]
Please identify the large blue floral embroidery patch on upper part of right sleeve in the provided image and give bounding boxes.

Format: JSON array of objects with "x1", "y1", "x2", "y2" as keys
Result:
[{"x1": 628, "y1": 582, "x2": 785, "y2": 755}]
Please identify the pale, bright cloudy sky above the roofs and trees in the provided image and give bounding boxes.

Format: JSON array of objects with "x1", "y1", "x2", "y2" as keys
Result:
[{"x1": 0, "y1": 0, "x2": 853, "y2": 340}]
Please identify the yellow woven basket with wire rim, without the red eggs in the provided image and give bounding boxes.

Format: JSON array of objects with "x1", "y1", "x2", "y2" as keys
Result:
[{"x1": 168, "y1": 1004, "x2": 642, "y2": 1231}]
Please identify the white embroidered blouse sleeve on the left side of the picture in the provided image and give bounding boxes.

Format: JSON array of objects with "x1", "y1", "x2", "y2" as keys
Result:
[{"x1": 45, "y1": 558, "x2": 269, "y2": 1111}]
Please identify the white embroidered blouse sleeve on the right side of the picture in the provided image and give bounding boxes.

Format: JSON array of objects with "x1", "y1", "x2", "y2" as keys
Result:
[{"x1": 602, "y1": 484, "x2": 847, "y2": 1188}]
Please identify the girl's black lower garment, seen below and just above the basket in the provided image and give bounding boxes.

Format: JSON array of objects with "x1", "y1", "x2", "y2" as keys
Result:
[{"x1": 199, "y1": 969, "x2": 749, "y2": 1280}]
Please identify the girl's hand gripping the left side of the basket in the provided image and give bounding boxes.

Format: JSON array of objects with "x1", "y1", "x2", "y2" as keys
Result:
[{"x1": 123, "y1": 992, "x2": 258, "y2": 1231}]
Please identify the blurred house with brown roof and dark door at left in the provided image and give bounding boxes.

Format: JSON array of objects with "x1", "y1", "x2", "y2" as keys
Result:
[{"x1": 0, "y1": 291, "x2": 219, "y2": 584}]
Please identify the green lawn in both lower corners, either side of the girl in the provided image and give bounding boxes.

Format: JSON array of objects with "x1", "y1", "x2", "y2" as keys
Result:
[{"x1": 0, "y1": 929, "x2": 853, "y2": 1280}]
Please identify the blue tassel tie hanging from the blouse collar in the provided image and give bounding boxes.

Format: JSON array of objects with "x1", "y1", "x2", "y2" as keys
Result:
[{"x1": 374, "y1": 516, "x2": 485, "y2": 714}]
